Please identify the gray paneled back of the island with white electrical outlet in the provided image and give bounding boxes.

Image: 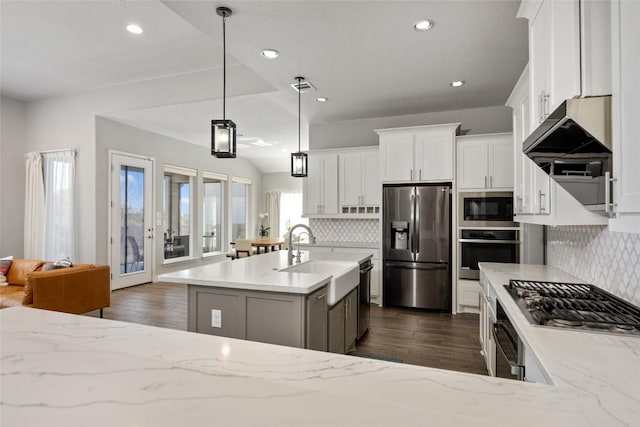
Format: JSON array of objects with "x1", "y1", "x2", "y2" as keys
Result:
[{"x1": 188, "y1": 284, "x2": 327, "y2": 351}]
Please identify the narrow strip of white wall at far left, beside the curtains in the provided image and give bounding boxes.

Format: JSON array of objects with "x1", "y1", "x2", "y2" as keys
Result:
[{"x1": 0, "y1": 96, "x2": 25, "y2": 258}]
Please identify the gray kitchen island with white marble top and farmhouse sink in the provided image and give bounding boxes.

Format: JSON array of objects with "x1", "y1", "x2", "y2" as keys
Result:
[{"x1": 160, "y1": 251, "x2": 372, "y2": 352}]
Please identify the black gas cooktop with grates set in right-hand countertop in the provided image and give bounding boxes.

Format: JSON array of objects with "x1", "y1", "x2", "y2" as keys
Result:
[{"x1": 505, "y1": 280, "x2": 640, "y2": 336}]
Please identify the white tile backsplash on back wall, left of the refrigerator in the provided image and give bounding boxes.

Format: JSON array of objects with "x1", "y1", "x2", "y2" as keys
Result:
[{"x1": 309, "y1": 218, "x2": 380, "y2": 243}]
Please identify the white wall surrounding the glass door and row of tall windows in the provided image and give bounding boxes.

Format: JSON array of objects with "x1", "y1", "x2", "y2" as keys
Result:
[{"x1": 96, "y1": 117, "x2": 264, "y2": 274}]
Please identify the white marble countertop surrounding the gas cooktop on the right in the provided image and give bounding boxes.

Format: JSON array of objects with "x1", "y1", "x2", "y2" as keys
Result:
[{"x1": 480, "y1": 263, "x2": 640, "y2": 426}]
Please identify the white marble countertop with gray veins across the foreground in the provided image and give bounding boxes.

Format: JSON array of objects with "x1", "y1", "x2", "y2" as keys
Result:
[{"x1": 0, "y1": 307, "x2": 592, "y2": 427}]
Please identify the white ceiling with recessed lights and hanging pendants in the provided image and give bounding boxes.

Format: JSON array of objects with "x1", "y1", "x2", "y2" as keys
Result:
[{"x1": 0, "y1": 0, "x2": 527, "y2": 172}]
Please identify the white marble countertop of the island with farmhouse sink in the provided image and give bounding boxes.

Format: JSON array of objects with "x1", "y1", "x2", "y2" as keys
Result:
[{"x1": 159, "y1": 251, "x2": 373, "y2": 295}]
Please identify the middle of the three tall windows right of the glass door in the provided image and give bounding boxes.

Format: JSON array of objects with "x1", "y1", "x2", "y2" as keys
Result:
[{"x1": 202, "y1": 172, "x2": 227, "y2": 254}]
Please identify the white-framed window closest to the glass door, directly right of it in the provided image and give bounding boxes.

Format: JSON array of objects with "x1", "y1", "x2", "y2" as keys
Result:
[{"x1": 162, "y1": 165, "x2": 196, "y2": 259}]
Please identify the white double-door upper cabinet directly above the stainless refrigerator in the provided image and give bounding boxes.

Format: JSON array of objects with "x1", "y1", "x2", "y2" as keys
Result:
[{"x1": 376, "y1": 123, "x2": 460, "y2": 183}]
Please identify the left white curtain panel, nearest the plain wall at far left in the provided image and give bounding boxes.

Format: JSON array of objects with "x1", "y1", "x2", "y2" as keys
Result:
[{"x1": 24, "y1": 152, "x2": 44, "y2": 259}]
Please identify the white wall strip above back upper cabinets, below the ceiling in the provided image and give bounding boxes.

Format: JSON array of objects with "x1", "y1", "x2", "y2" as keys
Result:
[{"x1": 309, "y1": 106, "x2": 512, "y2": 150}]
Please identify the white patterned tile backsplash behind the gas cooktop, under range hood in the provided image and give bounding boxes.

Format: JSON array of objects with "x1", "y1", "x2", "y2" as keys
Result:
[{"x1": 547, "y1": 226, "x2": 640, "y2": 306}]
